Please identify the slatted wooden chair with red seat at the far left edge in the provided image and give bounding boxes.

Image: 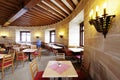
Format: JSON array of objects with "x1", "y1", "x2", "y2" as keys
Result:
[{"x1": 0, "y1": 53, "x2": 15, "y2": 78}]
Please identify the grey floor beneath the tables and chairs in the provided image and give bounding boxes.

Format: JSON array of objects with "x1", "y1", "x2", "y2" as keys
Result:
[{"x1": 0, "y1": 49, "x2": 79, "y2": 80}]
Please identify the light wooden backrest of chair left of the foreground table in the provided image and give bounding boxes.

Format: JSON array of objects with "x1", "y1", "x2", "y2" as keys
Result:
[{"x1": 30, "y1": 60, "x2": 38, "y2": 80}]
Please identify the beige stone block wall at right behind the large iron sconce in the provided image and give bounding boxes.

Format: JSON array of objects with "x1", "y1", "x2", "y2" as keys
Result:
[{"x1": 84, "y1": 0, "x2": 120, "y2": 80}]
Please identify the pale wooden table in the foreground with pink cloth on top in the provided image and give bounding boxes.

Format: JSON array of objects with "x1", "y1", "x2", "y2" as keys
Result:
[{"x1": 42, "y1": 61, "x2": 78, "y2": 79}]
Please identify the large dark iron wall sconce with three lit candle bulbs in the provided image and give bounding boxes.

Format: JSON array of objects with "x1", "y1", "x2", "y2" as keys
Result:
[{"x1": 89, "y1": 3, "x2": 115, "y2": 38}]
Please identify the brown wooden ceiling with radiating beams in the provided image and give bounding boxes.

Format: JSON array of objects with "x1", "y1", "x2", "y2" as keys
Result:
[{"x1": 0, "y1": 0, "x2": 80, "y2": 27}]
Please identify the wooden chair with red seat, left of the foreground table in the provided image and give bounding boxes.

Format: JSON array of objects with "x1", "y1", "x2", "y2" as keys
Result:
[{"x1": 30, "y1": 60, "x2": 49, "y2": 80}]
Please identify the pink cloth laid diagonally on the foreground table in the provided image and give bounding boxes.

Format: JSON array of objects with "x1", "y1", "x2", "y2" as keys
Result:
[{"x1": 49, "y1": 62, "x2": 70, "y2": 74}]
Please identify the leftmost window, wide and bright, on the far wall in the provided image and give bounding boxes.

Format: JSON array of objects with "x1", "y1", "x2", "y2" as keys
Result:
[{"x1": 20, "y1": 31, "x2": 31, "y2": 43}]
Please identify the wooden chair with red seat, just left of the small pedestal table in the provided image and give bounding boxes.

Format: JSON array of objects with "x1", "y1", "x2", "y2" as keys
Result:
[{"x1": 16, "y1": 51, "x2": 28, "y2": 66}]
